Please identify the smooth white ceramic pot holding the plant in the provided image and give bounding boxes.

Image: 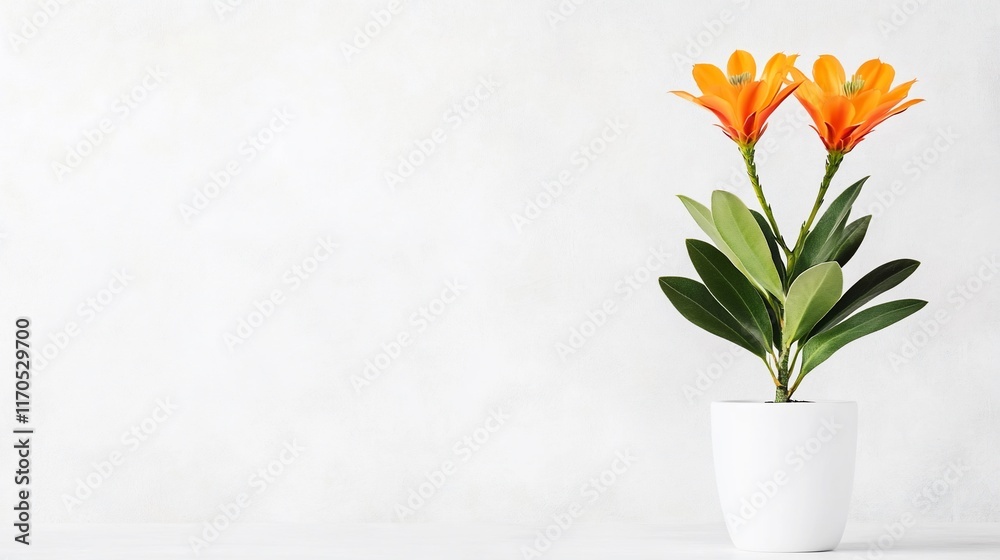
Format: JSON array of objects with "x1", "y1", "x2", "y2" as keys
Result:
[{"x1": 712, "y1": 401, "x2": 858, "y2": 552}]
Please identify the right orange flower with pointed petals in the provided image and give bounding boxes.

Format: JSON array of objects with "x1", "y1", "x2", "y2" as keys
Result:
[{"x1": 791, "y1": 54, "x2": 923, "y2": 154}]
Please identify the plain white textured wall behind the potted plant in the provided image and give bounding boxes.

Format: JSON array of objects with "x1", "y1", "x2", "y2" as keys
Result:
[{"x1": 0, "y1": 0, "x2": 1000, "y2": 524}]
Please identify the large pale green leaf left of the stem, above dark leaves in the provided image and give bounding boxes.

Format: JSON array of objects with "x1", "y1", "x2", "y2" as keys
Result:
[{"x1": 712, "y1": 191, "x2": 785, "y2": 302}]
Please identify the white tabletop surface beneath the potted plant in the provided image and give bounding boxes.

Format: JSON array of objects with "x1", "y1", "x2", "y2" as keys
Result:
[{"x1": 9, "y1": 524, "x2": 1000, "y2": 560}]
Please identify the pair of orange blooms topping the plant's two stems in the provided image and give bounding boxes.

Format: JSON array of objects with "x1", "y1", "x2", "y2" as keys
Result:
[{"x1": 671, "y1": 51, "x2": 923, "y2": 154}]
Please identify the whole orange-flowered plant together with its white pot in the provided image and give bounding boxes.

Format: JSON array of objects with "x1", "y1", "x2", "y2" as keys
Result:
[{"x1": 660, "y1": 51, "x2": 927, "y2": 552}]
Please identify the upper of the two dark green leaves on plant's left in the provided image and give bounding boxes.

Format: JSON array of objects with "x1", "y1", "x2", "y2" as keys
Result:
[{"x1": 687, "y1": 239, "x2": 774, "y2": 349}]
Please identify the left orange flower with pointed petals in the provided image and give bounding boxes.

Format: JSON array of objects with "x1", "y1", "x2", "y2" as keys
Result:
[{"x1": 670, "y1": 51, "x2": 799, "y2": 146}]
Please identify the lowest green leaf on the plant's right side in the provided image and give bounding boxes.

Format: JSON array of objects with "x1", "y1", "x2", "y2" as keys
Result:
[{"x1": 800, "y1": 299, "x2": 927, "y2": 377}]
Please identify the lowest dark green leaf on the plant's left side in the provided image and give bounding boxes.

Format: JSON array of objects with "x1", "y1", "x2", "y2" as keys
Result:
[{"x1": 660, "y1": 276, "x2": 766, "y2": 358}]
